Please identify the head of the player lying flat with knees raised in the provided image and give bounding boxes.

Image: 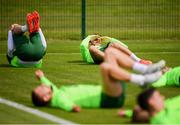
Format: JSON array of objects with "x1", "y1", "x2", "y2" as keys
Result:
[{"x1": 32, "y1": 84, "x2": 52, "y2": 106}]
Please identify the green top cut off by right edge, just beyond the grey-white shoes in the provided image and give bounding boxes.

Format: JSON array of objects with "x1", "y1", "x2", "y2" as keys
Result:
[{"x1": 152, "y1": 66, "x2": 180, "y2": 87}]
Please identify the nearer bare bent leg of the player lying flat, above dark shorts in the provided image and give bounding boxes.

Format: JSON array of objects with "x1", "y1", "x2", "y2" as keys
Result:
[{"x1": 100, "y1": 62, "x2": 130, "y2": 97}]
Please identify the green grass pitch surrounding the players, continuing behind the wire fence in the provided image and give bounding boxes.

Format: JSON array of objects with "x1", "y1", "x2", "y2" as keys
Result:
[{"x1": 0, "y1": 0, "x2": 180, "y2": 124}]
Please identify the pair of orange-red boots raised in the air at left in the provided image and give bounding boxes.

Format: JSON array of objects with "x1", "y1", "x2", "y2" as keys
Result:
[{"x1": 26, "y1": 11, "x2": 39, "y2": 33}]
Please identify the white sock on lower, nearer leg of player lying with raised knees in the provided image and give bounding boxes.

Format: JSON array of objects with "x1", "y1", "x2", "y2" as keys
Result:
[{"x1": 130, "y1": 74, "x2": 145, "y2": 86}]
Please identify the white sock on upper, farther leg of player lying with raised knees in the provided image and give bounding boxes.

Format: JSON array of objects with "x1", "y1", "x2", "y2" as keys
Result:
[{"x1": 133, "y1": 62, "x2": 148, "y2": 74}]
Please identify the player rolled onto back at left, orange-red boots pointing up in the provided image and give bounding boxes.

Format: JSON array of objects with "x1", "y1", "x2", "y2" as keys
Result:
[{"x1": 7, "y1": 11, "x2": 46, "y2": 67}]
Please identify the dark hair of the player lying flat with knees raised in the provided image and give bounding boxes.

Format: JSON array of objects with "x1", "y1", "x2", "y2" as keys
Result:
[{"x1": 31, "y1": 91, "x2": 49, "y2": 106}]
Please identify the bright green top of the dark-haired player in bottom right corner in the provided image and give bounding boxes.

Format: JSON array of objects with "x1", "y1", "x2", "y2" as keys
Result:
[{"x1": 150, "y1": 96, "x2": 180, "y2": 124}]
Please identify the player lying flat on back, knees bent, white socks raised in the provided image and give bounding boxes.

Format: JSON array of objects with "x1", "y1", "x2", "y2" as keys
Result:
[{"x1": 32, "y1": 48, "x2": 165, "y2": 112}]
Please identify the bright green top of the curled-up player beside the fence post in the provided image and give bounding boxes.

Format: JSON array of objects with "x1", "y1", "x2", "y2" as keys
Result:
[{"x1": 80, "y1": 35, "x2": 128, "y2": 63}]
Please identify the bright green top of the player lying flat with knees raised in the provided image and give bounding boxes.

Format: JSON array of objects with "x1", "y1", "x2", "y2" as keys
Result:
[{"x1": 40, "y1": 77, "x2": 102, "y2": 111}]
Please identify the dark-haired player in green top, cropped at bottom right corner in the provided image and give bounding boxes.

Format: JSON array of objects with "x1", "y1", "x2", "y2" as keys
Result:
[{"x1": 138, "y1": 88, "x2": 180, "y2": 124}]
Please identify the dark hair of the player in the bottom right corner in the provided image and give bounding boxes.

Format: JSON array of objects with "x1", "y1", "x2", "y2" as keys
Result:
[{"x1": 137, "y1": 88, "x2": 156, "y2": 110}]
